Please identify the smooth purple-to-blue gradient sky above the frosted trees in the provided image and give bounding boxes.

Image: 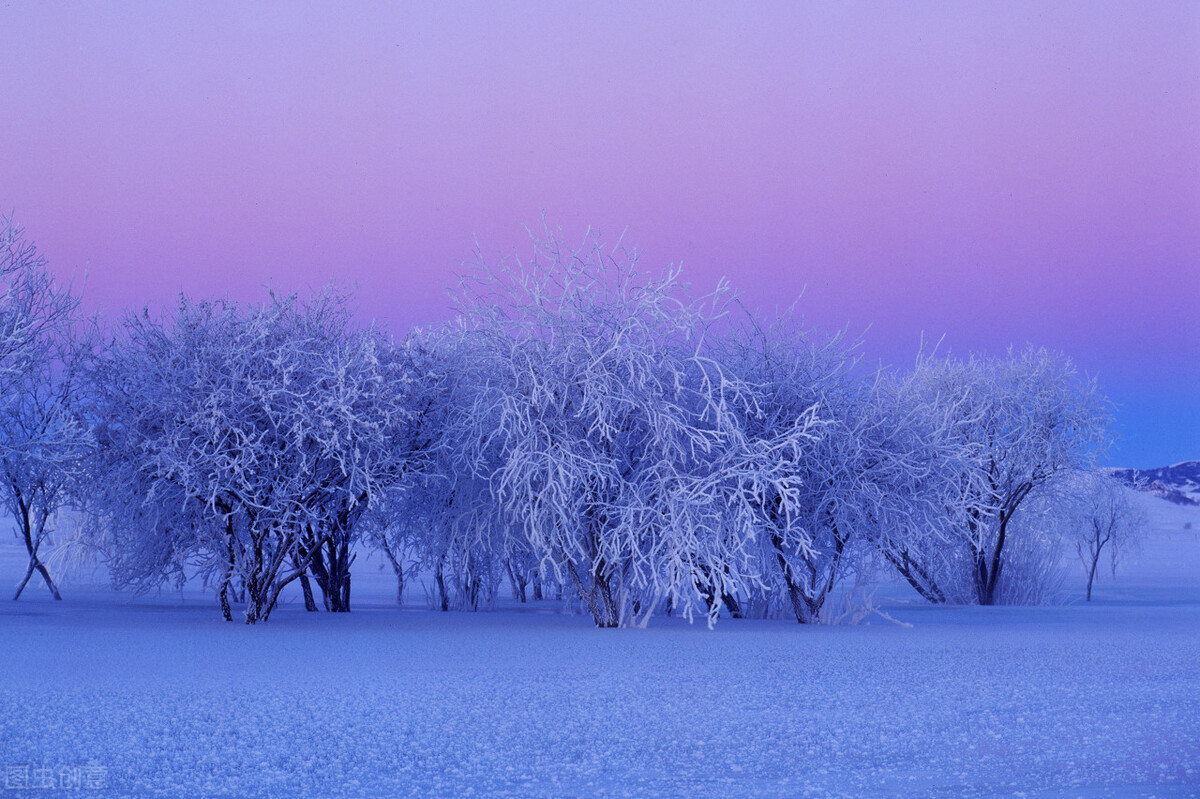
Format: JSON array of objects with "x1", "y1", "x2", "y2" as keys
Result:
[{"x1": 0, "y1": 0, "x2": 1200, "y2": 465}]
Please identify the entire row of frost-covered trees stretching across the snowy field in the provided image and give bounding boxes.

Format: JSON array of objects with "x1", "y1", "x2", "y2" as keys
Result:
[{"x1": 0, "y1": 220, "x2": 1136, "y2": 627}]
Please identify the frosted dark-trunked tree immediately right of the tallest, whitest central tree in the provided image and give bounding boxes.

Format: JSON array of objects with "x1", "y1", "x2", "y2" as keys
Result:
[{"x1": 718, "y1": 314, "x2": 870, "y2": 624}]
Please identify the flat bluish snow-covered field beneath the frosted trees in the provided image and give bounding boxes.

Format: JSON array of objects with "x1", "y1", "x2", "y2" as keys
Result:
[{"x1": 0, "y1": 495, "x2": 1200, "y2": 798}]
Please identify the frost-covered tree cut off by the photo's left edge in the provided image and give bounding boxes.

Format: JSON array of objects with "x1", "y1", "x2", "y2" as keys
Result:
[{"x1": 0, "y1": 217, "x2": 91, "y2": 599}]
